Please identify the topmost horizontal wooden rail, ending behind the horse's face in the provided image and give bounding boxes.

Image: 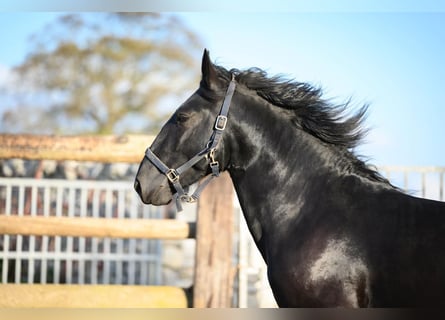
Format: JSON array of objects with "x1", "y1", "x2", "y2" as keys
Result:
[{"x1": 0, "y1": 134, "x2": 154, "y2": 163}]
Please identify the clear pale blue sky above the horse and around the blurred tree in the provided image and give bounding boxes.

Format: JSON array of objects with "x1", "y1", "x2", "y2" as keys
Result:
[{"x1": 0, "y1": 10, "x2": 445, "y2": 165}]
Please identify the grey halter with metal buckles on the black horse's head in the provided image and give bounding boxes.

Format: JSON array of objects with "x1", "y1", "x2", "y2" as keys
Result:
[{"x1": 145, "y1": 74, "x2": 236, "y2": 211}]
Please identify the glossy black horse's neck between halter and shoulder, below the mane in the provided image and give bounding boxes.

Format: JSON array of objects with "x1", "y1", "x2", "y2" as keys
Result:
[{"x1": 225, "y1": 90, "x2": 360, "y2": 261}]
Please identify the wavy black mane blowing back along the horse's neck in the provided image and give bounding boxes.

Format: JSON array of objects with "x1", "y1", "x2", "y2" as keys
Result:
[{"x1": 215, "y1": 66, "x2": 391, "y2": 185}]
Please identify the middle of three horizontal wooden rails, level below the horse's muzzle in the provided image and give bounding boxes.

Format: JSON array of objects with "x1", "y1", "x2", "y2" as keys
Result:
[{"x1": 0, "y1": 215, "x2": 195, "y2": 239}]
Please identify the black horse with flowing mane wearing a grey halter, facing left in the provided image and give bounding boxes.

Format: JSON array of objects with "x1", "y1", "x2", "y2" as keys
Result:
[{"x1": 135, "y1": 51, "x2": 445, "y2": 307}]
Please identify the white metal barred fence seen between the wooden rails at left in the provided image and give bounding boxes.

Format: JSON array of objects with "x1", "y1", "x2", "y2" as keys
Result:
[{"x1": 0, "y1": 178, "x2": 162, "y2": 285}]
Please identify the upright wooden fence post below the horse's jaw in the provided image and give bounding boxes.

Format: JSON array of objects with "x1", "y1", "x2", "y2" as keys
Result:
[{"x1": 193, "y1": 173, "x2": 234, "y2": 308}]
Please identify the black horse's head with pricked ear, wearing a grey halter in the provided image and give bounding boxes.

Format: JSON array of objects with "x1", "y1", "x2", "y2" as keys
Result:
[{"x1": 134, "y1": 50, "x2": 235, "y2": 208}]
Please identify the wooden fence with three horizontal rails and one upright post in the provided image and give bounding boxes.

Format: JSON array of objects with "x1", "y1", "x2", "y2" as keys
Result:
[{"x1": 0, "y1": 135, "x2": 234, "y2": 308}]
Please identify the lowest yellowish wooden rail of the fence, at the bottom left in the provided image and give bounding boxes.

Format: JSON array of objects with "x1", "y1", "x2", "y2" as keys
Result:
[{"x1": 0, "y1": 284, "x2": 190, "y2": 308}]
